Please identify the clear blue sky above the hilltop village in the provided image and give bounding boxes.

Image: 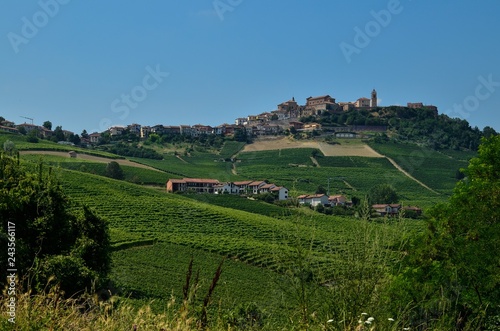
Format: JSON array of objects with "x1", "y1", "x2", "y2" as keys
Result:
[{"x1": 0, "y1": 0, "x2": 500, "y2": 133}]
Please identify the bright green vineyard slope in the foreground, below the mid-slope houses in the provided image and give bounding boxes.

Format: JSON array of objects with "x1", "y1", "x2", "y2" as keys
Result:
[{"x1": 20, "y1": 163, "x2": 420, "y2": 324}]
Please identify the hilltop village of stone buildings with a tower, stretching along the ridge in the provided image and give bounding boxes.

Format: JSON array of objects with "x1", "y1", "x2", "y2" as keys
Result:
[{"x1": 0, "y1": 89, "x2": 437, "y2": 145}]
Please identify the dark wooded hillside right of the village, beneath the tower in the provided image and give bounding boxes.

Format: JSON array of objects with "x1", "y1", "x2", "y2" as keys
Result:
[{"x1": 301, "y1": 106, "x2": 496, "y2": 151}]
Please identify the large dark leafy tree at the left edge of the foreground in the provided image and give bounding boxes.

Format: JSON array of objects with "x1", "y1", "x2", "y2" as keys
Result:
[{"x1": 0, "y1": 153, "x2": 110, "y2": 296}]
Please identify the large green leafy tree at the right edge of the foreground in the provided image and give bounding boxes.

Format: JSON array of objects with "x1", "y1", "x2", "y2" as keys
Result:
[{"x1": 394, "y1": 136, "x2": 500, "y2": 330}]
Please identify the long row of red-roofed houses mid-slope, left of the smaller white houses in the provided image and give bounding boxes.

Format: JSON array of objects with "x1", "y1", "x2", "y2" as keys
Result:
[{"x1": 166, "y1": 178, "x2": 288, "y2": 200}]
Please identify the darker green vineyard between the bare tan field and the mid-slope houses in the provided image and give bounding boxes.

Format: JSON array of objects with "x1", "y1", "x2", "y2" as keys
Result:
[{"x1": 237, "y1": 149, "x2": 444, "y2": 207}]
